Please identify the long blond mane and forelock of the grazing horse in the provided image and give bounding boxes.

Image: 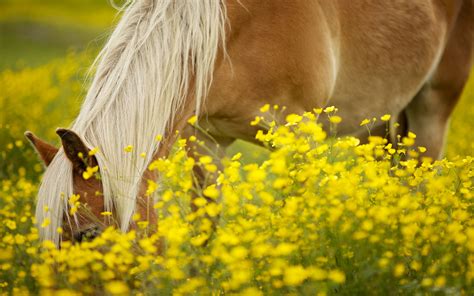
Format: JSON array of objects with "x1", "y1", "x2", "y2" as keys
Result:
[{"x1": 36, "y1": 0, "x2": 226, "y2": 243}]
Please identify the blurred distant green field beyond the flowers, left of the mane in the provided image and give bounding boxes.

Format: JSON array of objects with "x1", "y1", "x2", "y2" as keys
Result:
[{"x1": 0, "y1": 0, "x2": 117, "y2": 69}]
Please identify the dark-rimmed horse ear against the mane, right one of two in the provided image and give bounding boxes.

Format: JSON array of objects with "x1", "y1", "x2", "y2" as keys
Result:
[{"x1": 56, "y1": 128, "x2": 97, "y2": 173}]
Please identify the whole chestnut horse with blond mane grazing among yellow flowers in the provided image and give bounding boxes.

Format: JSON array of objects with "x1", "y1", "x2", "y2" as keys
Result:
[{"x1": 26, "y1": 0, "x2": 474, "y2": 244}]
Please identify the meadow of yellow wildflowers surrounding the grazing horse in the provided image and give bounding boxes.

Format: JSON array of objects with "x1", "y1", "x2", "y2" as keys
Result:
[{"x1": 0, "y1": 0, "x2": 474, "y2": 295}]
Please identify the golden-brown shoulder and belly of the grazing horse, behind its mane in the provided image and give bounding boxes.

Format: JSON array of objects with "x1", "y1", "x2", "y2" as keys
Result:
[{"x1": 204, "y1": 0, "x2": 470, "y2": 158}]
